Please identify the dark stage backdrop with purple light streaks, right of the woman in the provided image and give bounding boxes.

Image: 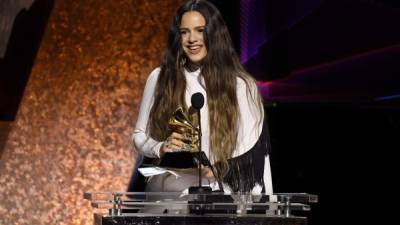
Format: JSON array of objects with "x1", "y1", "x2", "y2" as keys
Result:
[{"x1": 212, "y1": 0, "x2": 400, "y2": 225}]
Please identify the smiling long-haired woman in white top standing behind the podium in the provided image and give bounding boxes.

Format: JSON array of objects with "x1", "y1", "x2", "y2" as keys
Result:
[{"x1": 133, "y1": 0, "x2": 272, "y2": 194}]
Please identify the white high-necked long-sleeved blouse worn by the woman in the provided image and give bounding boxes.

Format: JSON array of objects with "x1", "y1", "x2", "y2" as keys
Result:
[{"x1": 132, "y1": 68, "x2": 272, "y2": 194}]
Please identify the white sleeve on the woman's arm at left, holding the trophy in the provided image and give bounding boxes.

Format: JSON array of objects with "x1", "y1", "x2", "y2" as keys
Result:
[{"x1": 132, "y1": 68, "x2": 163, "y2": 158}]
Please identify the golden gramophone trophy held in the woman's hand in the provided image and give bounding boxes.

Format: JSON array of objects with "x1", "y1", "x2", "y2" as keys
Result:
[{"x1": 168, "y1": 107, "x2": 199, "y2": 152}]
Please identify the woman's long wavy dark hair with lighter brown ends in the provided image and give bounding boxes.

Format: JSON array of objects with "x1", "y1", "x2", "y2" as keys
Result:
[{"x1": 149, "y1": 0, "x2": 262, "y2": 177}]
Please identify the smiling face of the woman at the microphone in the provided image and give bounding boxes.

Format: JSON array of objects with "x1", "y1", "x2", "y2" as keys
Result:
[{"x1": 180, "y1": 11, "x2": 207, "y2": 65}]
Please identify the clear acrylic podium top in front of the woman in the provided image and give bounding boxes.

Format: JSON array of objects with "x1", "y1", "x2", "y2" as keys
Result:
[{"x1": 84, "y1": 192, "x2": 318, "y2": 225}]
